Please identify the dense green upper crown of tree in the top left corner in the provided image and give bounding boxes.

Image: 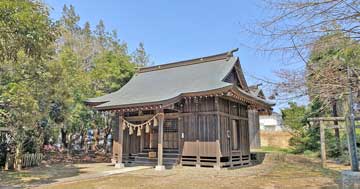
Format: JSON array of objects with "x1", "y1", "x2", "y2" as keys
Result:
[{"x1": 0, "y1": 0, "x2": 57, "y2": 61}]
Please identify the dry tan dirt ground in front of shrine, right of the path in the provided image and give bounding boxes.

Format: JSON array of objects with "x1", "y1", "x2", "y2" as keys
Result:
[{"x1": 36, "y1": 156, "x2": 339, "y2": 189}]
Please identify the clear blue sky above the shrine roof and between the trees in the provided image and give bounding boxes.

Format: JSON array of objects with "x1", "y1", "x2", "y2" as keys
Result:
[{"x1": 44, "y1": 0, "x2": 290, "y2": 110}]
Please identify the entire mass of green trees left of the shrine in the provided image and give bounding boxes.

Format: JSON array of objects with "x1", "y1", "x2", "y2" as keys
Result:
[{"x1": 0, "y1": 0, "x2": 141, "y2": 166}]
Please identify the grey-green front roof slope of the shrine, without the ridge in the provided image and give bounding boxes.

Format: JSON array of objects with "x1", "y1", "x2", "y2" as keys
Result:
[{"x1": 87, "y1": 57, "x2": 237, "y2": 108}]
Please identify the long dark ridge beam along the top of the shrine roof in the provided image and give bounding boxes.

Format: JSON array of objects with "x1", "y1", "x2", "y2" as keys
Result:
[{"x1": 138, "y1": 48, "x2": 239, "y2": 73}]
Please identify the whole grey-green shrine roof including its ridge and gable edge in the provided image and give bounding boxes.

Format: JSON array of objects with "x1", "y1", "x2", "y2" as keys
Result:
[{"x1": 87, "y1": 50, "x2": 270, "y2": 110}]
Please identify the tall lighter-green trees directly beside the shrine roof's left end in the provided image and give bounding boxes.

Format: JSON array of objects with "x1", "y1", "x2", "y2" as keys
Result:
[{"x1": 52, "y1": 6, "x2": 135, "y2": 145}]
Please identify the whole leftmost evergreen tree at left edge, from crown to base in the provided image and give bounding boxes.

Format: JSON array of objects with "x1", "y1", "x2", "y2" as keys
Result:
[{"x1": 0, "y1": 0, "x2": 58, "y2": 169}]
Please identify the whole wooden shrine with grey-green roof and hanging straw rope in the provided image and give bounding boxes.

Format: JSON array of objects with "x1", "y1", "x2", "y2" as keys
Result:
[{"x1": 86, "y1": 49, "x2": 272, "y2": 170}]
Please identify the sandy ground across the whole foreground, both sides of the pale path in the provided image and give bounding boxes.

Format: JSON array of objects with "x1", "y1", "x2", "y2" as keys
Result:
[{"x1": 0, "y1": 152, "x2": 341, "y2": 189}]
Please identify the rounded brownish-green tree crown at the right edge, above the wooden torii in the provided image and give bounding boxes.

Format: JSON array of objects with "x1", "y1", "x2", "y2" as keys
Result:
[{"x1": 306, "y1": 32, "x2": 360, "y2": 103}]
